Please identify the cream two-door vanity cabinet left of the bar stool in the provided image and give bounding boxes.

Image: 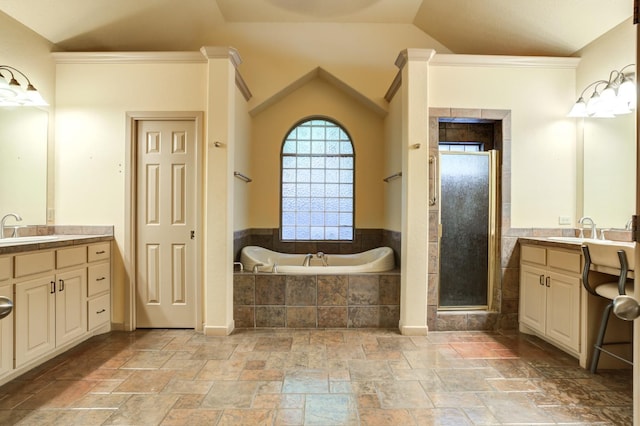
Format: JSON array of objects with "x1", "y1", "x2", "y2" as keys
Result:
[{"x1": 519, "y1": 244, "x2": 582, "y2": 357}]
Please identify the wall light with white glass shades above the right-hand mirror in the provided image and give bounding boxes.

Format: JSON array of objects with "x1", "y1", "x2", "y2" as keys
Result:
[{"x1": 568, "y1": 64, "x2": 637, "y2": 118}]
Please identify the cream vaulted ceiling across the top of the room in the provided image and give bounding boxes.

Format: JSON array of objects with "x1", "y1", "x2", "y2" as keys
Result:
[{"x1": 0, "y1": 0, "x2": 633, "y2": 56}]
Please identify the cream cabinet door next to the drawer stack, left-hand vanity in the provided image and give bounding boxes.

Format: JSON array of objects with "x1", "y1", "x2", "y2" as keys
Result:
[{"x1": 56, "y1": 268, "x2": 87, "y2": 346}]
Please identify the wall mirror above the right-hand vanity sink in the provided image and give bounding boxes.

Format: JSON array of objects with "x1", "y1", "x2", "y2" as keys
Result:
[{"x1": 583, "y1": 113, "x2": 636, "y2": 229}]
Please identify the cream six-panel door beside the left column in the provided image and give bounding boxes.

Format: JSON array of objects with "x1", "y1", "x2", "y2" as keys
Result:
[{"x1": 136, "y1": 120, "x2": 196, "y2": 328}]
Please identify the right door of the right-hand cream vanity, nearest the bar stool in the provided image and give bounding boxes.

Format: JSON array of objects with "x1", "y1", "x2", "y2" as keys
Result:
[{"x1": 546, "y1": 272, "x2": 580, "y2": 352}]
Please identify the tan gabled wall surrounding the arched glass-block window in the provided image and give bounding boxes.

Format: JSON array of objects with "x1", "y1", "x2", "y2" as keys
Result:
[{"x1": 249, "y1": 78, "x2": 385, "y2": 228}]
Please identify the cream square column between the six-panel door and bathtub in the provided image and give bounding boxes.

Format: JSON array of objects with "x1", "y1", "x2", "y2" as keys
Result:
[{"x1": 201, "y1": 47, "x2": 241, "y2": 336}]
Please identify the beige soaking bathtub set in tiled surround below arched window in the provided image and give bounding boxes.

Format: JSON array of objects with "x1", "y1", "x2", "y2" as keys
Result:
[{"x1": 240, "y1": 246, "x2": 395, "y2": 274}]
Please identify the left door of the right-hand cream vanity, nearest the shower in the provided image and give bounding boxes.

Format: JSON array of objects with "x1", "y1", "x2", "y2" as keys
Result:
[{"x1": 520, "y1": 265, "x2": 547, "y2": 333}]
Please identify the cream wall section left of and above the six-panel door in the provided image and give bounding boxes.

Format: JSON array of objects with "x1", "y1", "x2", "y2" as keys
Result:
[{"x1": 55, "y1": 63, "x2": 206, "y2": 324}]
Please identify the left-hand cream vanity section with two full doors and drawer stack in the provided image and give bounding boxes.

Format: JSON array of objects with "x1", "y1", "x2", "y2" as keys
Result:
[{"x1": 11, "y1": 242, "x2": 111, "y2": 369}]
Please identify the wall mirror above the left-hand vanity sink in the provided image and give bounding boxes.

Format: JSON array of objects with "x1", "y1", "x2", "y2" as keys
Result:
[{"x1": 0, "y1": 107, "x2": 49, "y2": 225}]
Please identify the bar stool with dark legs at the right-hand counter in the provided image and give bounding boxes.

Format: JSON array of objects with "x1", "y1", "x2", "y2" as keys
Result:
[{"x1": 582, "y1": 241, "x2": 634, "y2": 374}]
